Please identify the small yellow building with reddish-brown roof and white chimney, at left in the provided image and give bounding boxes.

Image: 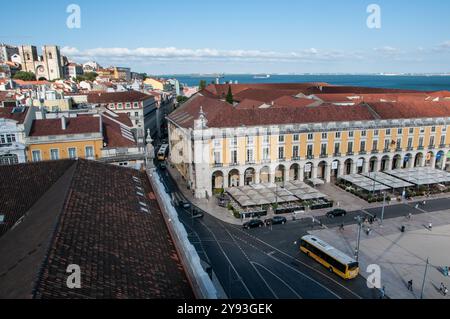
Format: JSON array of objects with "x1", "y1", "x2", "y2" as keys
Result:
[{"x1": 27, "y1": 116, "x2": 103, "y2": 162}]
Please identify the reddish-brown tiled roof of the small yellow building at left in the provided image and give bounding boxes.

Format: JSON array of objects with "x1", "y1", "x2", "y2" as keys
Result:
[{"x1": 29, "y1": 116, "x2": 101, "y2": 136}]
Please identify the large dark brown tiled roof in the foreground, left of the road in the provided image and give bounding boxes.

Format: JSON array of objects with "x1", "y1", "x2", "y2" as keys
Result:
[{"x1": 0, "y1": 160, "x2": 194, "y2": 299}]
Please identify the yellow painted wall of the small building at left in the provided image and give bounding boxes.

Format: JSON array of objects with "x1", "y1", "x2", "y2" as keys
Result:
[{"x1": 28, "y1": 139, "x2": 103, "y2": 161}]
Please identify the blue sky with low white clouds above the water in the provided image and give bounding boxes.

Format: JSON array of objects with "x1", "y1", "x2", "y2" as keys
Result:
[{"x1": 0, "y1": 0, "x2": 450, "y2": 74}]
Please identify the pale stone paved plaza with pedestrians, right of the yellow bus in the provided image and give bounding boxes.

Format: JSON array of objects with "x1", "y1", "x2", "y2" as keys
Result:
[{"x1": 312, "y1": 210, "x2": 450, "y2": 299}]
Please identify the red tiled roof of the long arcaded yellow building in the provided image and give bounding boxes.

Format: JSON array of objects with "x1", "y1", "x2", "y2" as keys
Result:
[{"x1": 169, "y1": 83, "x2": 450, "y2": 128}]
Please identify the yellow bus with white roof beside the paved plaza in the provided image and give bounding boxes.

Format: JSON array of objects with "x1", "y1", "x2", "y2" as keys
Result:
[{"x1": 300, "y1": 235, "x2": 359, "y2": 279}]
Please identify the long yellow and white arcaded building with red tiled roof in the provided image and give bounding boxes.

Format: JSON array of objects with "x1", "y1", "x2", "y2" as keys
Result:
[{"x1": 168, "y1": 83, "x2": 450, "y2": 198}]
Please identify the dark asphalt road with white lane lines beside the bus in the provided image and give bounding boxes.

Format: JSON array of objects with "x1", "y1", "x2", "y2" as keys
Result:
[{"x1": 160, "y1": 171, "x2": 400, "y2": 299}]
